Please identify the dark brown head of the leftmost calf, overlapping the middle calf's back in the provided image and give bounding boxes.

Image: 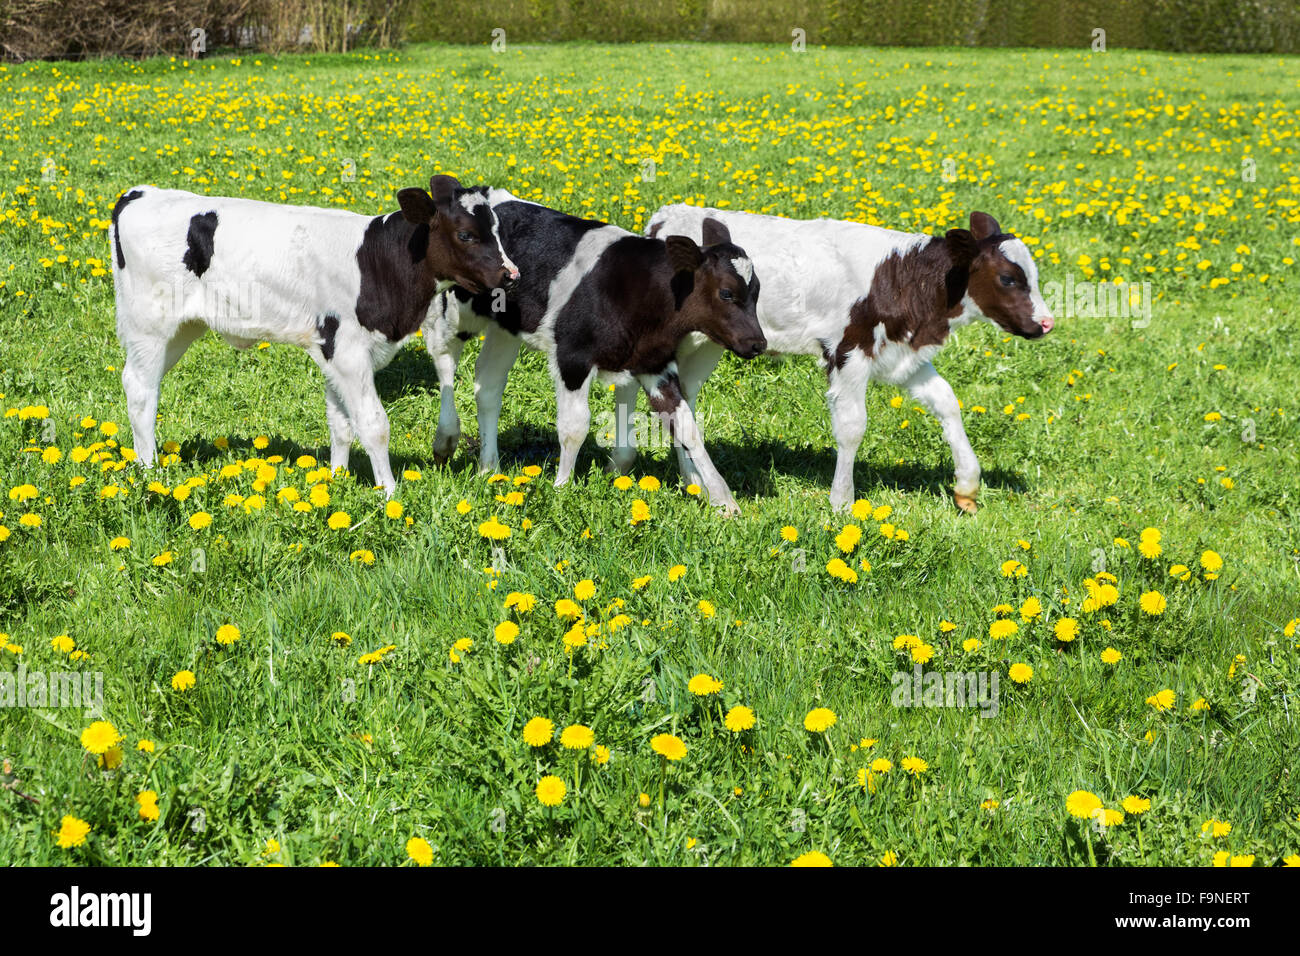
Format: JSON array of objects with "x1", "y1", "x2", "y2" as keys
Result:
[{"x1": 398, "y1": 176, "x2": 519, "y2": 293}]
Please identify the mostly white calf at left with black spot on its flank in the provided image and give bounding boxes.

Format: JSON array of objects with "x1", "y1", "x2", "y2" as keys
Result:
[{"x1": 112, "y1": 176, "x2": 519, "y2": 494}]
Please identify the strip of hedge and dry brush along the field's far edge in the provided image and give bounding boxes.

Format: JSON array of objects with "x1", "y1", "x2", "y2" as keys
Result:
[{"x1": 0, "y1": 0, "x2": 1300, "y2": 60}]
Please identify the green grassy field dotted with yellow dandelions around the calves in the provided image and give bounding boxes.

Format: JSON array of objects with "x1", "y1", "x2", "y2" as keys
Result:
[{"x1": 0, "y1": 46, "x2": 1300, "y2": 866}]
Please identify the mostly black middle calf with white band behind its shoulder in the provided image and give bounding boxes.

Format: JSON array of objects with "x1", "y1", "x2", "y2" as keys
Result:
[{"x1": 425, "y1": 190, "x2": 767, "y2": 511}]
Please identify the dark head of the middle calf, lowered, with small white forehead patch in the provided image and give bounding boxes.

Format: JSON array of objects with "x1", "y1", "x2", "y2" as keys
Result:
[{"x1": 664, "y1": 219, "x2": 767, "y2": 359}]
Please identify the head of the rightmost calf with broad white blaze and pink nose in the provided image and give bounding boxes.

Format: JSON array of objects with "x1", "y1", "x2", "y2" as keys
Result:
[{"x1": 966, "y1": 212, "x2": 1054, "y2": 338}]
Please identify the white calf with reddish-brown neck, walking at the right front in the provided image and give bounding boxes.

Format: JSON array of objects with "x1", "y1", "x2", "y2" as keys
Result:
[{"x1": 642, "y1": 206, "x2": 1053, "y2": 514}]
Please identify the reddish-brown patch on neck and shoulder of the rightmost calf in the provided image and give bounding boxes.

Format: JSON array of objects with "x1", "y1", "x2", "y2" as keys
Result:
[{"x1": 826, "y1": 229, "x2": 980, "y2": 368}]
